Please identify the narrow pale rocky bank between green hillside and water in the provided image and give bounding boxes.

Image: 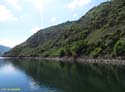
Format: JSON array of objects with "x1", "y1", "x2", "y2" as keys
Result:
[{"x1": 2, "y1": 57, "x2": 125, "y2": 65}]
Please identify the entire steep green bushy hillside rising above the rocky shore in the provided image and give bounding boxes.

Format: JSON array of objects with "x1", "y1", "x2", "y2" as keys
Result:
[{"x1": 5, "y1": 0, "x2": 125, "y2": 57}]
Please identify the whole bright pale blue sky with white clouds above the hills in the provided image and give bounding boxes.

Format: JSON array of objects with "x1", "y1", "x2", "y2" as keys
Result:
[{"x1": 0, "y1": 0, "x2": 107, "y2": 47}]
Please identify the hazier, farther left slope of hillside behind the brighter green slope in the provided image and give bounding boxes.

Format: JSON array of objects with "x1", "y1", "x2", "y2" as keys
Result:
[{"x1": 5, "y1": 21, "x2": 74, "y2": 56}]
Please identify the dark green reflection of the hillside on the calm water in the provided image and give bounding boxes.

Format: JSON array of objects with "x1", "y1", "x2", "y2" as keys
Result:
[{"x1": 10, "y1": 60, "x2": 125, "y2": 92}]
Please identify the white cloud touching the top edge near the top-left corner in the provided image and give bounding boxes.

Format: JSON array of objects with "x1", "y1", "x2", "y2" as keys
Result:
[{"x1": 4, "y1": 0, "x2": 22, "y2": 11}]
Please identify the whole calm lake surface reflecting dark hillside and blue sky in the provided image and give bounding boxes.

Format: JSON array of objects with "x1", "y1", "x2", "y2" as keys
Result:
[{"x1": 0, "y1": 58, "x2": 125, "y2": 92}]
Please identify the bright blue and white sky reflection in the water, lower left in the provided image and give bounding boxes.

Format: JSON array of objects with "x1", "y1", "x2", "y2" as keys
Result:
[{"x1": 0, "y1": 60, "x2": 62, "y2": 92}]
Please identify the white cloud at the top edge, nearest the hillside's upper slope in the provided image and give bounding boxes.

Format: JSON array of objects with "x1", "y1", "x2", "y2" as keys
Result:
[{"x1": 67, "y1": 0, "x2": 91, "y2": 10}]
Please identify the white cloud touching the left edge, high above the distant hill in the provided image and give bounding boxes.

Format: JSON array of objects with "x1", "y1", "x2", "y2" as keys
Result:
[{"x1": 0, "y1": 5, "x2": 18, "y2": 22}]
